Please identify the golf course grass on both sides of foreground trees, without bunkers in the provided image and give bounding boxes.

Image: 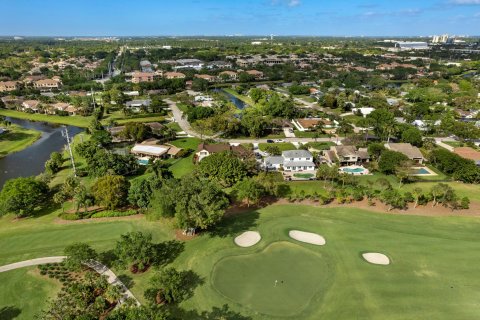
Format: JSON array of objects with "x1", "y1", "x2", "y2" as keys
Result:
[{"x1": 0, "y1": 205, "x2": 480, "y2": 319}]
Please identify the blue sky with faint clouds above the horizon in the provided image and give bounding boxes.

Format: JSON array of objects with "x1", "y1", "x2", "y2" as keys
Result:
[{"x1": 0, "y1": 0, "x2": 480, "y2": 36}]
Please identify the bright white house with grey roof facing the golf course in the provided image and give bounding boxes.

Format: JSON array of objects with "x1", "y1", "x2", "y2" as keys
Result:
[{"x1": 264, "y1": 150, "x2": 315, "y2": 172}]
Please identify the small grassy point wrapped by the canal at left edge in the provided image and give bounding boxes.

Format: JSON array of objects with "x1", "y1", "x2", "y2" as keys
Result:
[{"x1": 0, "y1": 125, "x2": 42, "y2": 158}]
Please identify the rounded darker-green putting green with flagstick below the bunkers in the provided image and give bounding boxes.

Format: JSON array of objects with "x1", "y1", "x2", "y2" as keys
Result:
[{"x1": 212, "y1": 242, "x2": 331, "y2": 317}]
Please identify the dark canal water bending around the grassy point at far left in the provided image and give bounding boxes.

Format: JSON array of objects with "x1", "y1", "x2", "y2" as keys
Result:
[{"x1": 0, "y1": 118, "x2": 83, "y2": 188}]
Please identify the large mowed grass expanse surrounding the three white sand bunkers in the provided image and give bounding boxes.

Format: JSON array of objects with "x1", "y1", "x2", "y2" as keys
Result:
[{"x1": 174, "y1": 205, "x2": 480, "y2": 320}]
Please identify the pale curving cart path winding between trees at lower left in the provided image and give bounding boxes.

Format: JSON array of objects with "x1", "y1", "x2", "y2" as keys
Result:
[{"x1": 0, "y1": 256, "x2": 140, "y2": 305}]
